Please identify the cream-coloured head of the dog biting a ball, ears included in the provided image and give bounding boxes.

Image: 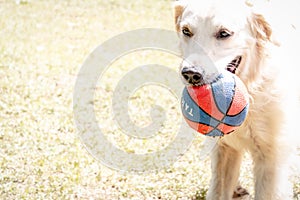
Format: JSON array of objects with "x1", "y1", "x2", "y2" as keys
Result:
[{"x1": 175, "y1": 0, "x2": 271, "y2": 85}]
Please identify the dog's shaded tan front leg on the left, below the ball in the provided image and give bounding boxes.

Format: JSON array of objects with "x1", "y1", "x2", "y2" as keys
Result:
[{"x1": 206, "y1": 144, "x2": 242, "y2": 200}]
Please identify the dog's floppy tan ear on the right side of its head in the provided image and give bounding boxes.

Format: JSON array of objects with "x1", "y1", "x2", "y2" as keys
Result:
[{"x1": 250, "y1": 14, "x2": 272, "y2": 42}]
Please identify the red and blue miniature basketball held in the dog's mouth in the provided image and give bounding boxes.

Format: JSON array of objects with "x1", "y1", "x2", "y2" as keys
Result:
[{"x1": 181, "y1": 71, "x2": 249, "y2": 137}]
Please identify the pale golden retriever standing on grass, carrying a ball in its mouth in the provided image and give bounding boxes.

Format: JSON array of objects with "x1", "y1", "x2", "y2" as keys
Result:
[{"x1": 174, "y1": 0, "x2": 299, "y2": 200}]
